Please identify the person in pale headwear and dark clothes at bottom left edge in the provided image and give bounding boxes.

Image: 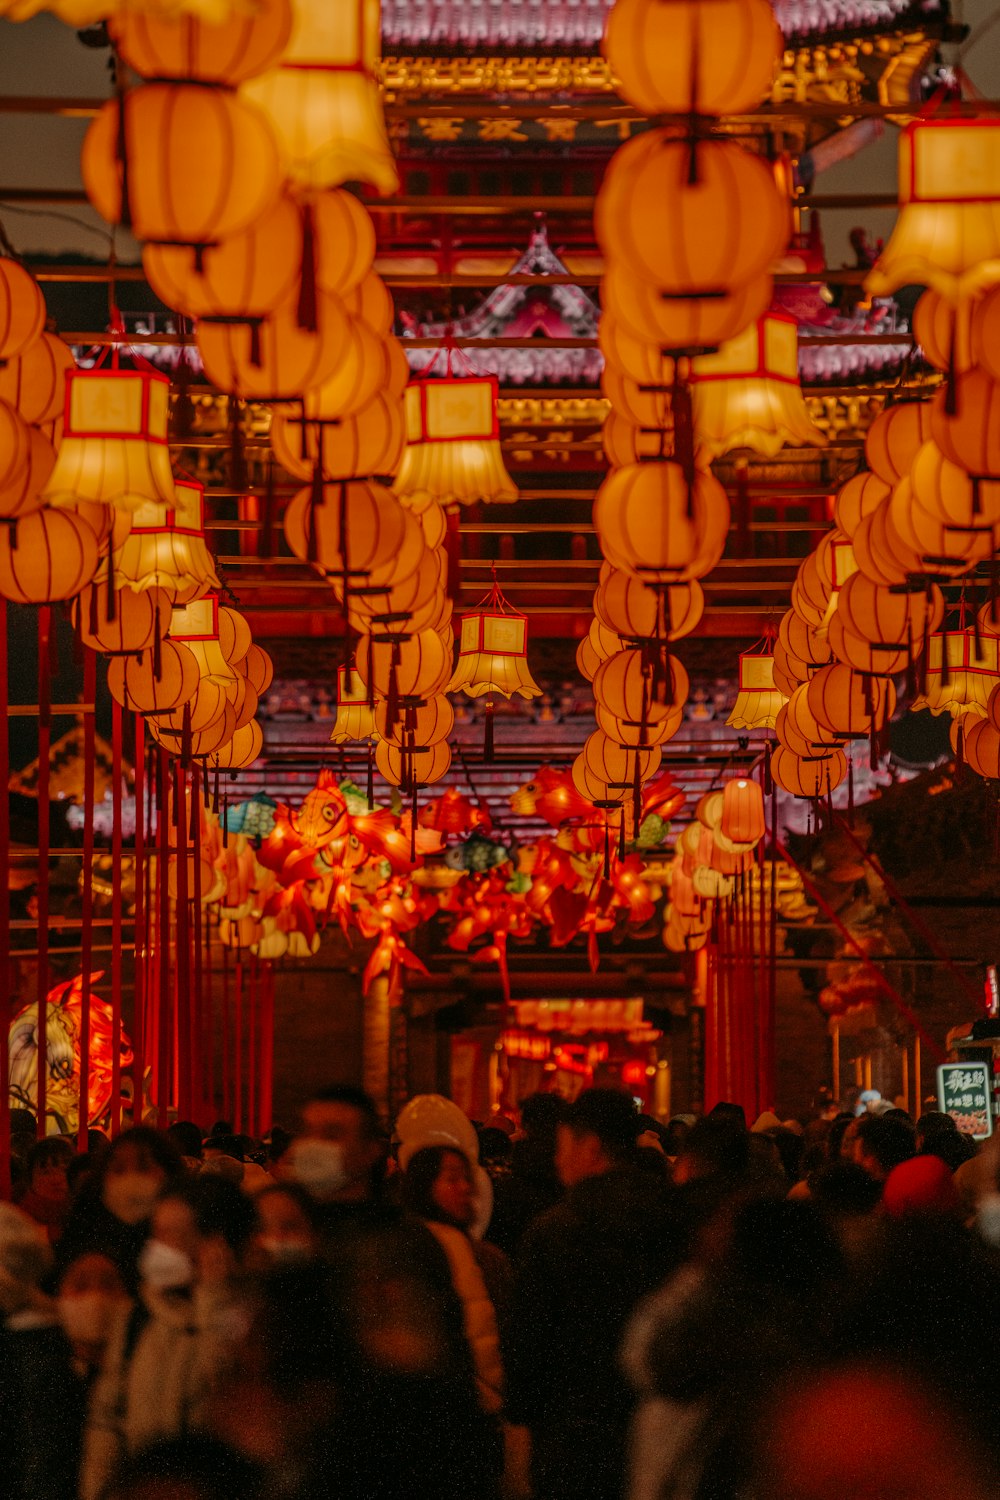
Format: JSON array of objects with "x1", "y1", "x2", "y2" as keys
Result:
[{"x1": 0, "y1": 1203, "x2": 85, "y2": 1500}]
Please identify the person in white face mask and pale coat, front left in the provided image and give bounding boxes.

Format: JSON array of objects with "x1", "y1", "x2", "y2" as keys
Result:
[{"x1": 79, "y1": 1176, "x2": 255, "y2": 1500}]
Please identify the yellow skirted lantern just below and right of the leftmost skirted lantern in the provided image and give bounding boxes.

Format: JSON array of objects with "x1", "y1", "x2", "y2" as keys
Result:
[{"x1": 114, "y1": 479, "x2": 222, "y2": 605}]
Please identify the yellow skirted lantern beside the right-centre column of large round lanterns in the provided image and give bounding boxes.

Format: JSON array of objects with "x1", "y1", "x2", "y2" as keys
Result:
[{"x1": 691, "y1": 314, "x2": 826, "y2": 458}]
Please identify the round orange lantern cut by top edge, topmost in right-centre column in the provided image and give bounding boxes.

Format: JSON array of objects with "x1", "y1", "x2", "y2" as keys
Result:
[{"x1": 604, "y1": 0, "x2": 783, "y2": 114}]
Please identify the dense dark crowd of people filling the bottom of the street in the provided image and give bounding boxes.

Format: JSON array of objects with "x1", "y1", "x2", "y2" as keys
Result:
[{"x1": 0, "y1": 1088, "x2": 1000, "y2": 1500}]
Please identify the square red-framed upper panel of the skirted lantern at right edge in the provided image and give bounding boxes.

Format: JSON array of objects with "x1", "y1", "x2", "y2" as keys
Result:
[{"x1": 900, "y1": 120, "x2": 1000, "y2": 203}]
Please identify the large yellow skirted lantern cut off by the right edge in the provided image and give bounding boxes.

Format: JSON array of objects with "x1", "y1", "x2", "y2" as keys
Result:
[{"x1": 865, "y1": 116, "x2": 1000, "y2": 303}]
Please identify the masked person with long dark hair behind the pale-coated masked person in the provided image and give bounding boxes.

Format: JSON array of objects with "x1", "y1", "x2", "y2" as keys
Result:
[{"x1": 57, "y1": 1125, "x2": 183, "y2": 1295}]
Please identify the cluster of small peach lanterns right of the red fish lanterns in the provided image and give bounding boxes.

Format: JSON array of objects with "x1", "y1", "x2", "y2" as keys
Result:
[{"x1": 663, "y1": 777, "x2": 766, "y2": 953}]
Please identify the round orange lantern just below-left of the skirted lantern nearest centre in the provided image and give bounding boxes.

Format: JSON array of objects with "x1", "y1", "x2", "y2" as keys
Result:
[{"x1": 285, "y1": 480, "x2": 424, "y2": 588}]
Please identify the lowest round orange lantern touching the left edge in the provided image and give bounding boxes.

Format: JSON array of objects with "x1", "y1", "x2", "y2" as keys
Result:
[{"x1": 0, "y1": 509, "x2": 99, "y2": 605}]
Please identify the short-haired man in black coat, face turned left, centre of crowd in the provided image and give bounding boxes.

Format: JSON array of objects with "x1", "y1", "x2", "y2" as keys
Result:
[{"x1": 507, "y1": 1089, "x2": 679, "y2": 1500}]
